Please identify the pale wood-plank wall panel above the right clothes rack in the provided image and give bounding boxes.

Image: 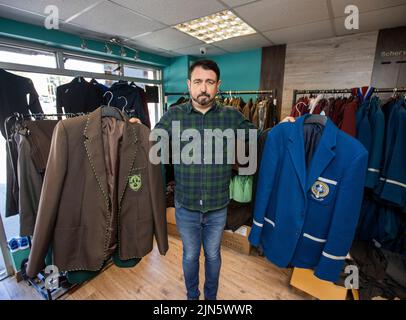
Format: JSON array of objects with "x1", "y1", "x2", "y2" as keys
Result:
[{"x1": 281, "y1": 31, "x2": 378, "y2": 117}]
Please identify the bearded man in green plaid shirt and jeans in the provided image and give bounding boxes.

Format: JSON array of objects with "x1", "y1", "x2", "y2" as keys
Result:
[{"x1": 130, "y1": 60, "x2": 294, "y2": 300}]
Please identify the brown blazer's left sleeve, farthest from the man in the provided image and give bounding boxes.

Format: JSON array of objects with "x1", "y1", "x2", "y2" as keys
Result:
[{"x1": 27, "y1": 121, "x2": 68, "y2": 277}]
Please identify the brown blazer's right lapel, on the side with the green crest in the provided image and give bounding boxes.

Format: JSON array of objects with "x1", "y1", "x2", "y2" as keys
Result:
[{"x1": 118, "y1": 121, "x2": 138, "y2": 208}]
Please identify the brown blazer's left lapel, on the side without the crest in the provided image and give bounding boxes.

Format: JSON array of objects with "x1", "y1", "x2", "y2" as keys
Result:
[{"x1": 83, "y1": 108, "x2": 111, "y2": 210}]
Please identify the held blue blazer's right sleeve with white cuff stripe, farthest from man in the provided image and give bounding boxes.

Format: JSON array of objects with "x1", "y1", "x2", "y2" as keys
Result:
[{"x1": 315, "y1": 150, "x2": 368, "y2": 282}]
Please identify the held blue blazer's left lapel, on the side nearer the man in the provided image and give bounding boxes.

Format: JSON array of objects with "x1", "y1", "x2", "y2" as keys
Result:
[{"x1": 288, "y1": 117, "x2": 306, "y2": 194}]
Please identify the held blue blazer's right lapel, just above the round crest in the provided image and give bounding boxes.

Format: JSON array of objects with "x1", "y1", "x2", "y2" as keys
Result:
[{"x1": 306, "y1": 119, "x2": 338, "y2": 192}]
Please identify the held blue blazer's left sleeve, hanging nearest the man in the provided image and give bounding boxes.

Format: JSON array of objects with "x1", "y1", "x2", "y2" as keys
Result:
[{"x1": 248, "y1": 127, "x2": 279, "y2": 247}]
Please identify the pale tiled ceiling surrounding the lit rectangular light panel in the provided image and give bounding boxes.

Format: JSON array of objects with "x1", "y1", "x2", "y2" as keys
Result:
[{"x1": 0, "y1": 0, "x2": 406, "y2": 57}]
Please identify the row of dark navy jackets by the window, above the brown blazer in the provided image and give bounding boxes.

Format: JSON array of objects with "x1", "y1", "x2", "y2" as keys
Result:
[{"x1": 56, "y1": 77, "x2": 151, "y2": 128}]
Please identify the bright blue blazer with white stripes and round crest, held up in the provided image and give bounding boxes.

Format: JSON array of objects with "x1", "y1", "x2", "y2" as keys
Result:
[{"x1": 249, "y1": 115, "x2": 368, "y2": 281}]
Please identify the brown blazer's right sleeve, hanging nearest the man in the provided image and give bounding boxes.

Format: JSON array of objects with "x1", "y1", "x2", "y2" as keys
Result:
[{"x1": 147, "y1": 138, "x2": 168, "y2": 255}]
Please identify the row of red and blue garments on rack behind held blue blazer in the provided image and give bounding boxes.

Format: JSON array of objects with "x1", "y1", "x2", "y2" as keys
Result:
[{"x1": 291, "y1": 87, "x2": 406, "y2": 255}]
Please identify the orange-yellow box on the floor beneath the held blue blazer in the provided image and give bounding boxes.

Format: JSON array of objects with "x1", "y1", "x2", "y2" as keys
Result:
[{"x1": 290, "y1": 268, "x2": 348, "y2": 300}]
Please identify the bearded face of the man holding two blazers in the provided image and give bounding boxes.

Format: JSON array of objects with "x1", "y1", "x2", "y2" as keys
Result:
[{"x1": 187, "y1": 67, "x2": 221, "y2": 107}]
